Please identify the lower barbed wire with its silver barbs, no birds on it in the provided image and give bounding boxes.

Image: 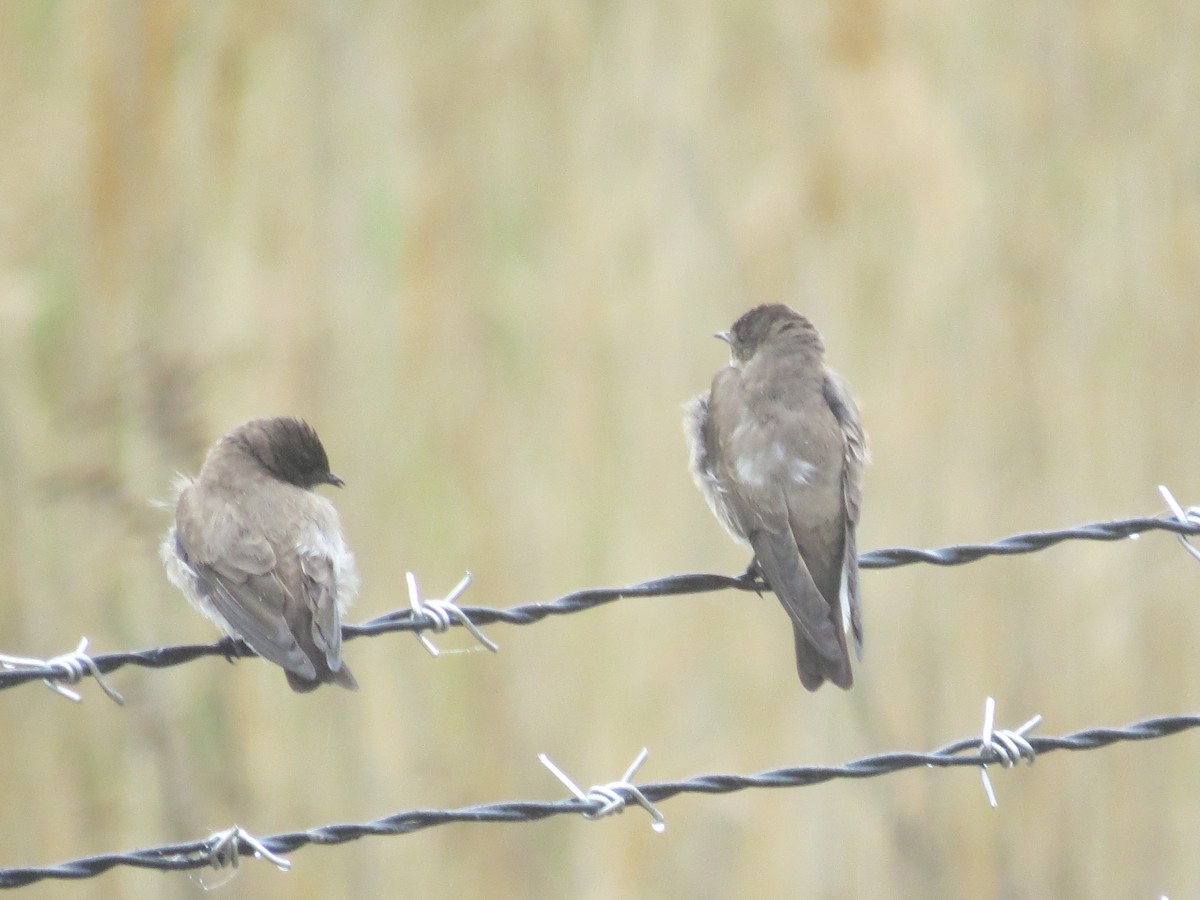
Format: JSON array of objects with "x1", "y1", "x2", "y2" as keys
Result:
[{"x1": 0, "y1": 698, "x2": 1200, "y2": 888}]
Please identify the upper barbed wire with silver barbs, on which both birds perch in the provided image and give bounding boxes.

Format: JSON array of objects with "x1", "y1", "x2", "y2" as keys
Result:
[{"x1": 0, "y1": 504, "x2": 1200, "y2": 700}]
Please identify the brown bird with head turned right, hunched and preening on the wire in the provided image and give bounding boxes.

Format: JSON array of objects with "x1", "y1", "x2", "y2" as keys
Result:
[{"x1": 160, "y1": 418, "x2": 359, "y2": 692}]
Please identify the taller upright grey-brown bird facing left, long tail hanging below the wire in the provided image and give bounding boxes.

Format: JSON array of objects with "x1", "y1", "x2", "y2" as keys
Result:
[{"x1": 684, "y1": 304, "x2": 866, "y2": 691}]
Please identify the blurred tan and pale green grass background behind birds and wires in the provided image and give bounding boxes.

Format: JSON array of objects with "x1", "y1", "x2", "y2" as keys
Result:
[{"x1": 0, "y1": 0, "x2": 1200, "y2": 898}]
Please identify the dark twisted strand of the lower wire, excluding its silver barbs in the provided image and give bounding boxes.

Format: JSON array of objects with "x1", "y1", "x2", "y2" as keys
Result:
[{"x1": 0, "y1": 714, "x2": 1200, "y2": 888}]
